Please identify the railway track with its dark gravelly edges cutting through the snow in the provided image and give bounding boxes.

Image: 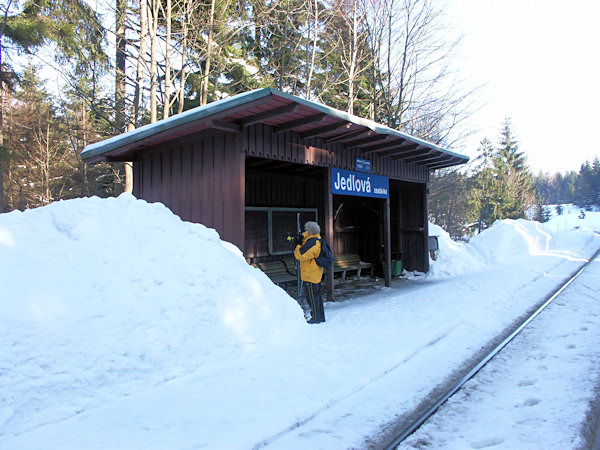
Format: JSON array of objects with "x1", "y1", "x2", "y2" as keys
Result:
[{"x1": 380, "y1": 249, "x2": 600, "y2": 450}]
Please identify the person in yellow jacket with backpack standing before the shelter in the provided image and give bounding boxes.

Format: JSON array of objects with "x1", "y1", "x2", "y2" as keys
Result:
[{"x1": 294, "y1": 222, "x2": 325, "y2": 323}]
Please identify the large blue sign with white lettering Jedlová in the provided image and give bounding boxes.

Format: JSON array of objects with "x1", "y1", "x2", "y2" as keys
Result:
[{"x1": 331, "y1": 167, "x2": 390, "y2": 198}]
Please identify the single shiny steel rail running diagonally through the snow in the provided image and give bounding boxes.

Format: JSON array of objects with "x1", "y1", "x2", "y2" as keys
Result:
[{"x1": 382, "y1": 249, "x2": 600, "y2": 450}]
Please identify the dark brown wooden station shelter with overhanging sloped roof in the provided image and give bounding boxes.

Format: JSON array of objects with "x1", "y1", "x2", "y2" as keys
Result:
[{"x1": 81, "y1": 88, "x2": 468, "y2": 299}]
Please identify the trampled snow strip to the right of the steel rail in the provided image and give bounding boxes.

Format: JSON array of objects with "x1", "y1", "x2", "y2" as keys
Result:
[{"x1": 400, "y1": 259, "x2": 600, "y2": 449}]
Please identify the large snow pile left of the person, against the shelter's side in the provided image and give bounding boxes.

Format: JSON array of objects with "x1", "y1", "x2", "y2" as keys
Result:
[{"x1": 0, "y1": 194, "x2": 308, "y2": 432}]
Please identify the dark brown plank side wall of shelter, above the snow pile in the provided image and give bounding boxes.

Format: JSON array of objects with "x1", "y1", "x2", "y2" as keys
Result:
[{"x1": 133, "y1": 130, "x2": 245, "y2": 248}]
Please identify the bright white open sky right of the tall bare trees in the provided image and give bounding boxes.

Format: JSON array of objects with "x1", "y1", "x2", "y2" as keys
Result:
[{"x1": 445, "y1": 0, "x2": 600, "y2": 173}]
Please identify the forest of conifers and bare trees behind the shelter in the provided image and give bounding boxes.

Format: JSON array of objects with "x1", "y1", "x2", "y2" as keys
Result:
[{"x1": 0, "y1": 0, "x2": 600, "y2": 238}]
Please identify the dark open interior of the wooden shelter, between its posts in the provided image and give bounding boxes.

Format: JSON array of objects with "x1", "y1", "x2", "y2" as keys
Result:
[{"x1": 244, "y1": 157, "x2": 427, "y2": 284}]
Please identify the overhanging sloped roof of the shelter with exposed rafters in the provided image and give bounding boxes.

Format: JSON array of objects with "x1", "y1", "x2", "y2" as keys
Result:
[{"x1": 81, "y1": 88, "x2": 469, "y2": 170}]
